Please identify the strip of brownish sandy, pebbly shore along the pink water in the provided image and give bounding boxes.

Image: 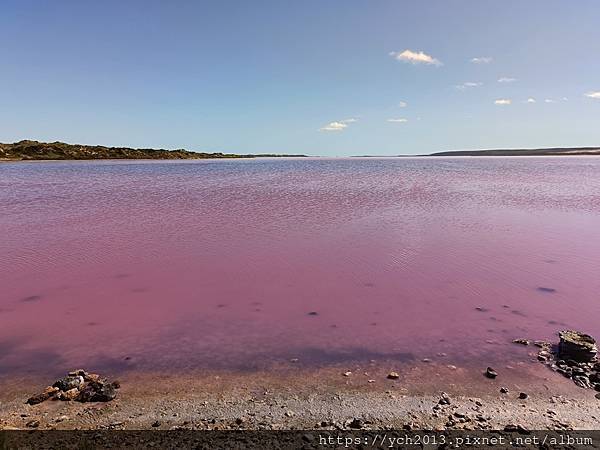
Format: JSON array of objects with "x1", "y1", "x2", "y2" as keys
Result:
[{"x1": 0, "y1": 361, "x2": 600, "y2": 430}]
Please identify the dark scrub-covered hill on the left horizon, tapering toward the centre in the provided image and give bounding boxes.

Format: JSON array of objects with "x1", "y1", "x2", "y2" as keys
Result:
[{"x1": 0, "y1": 141, "x2": 305, "y2": 160}]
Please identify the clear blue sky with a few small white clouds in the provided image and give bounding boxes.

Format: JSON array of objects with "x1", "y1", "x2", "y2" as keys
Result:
[{"x1": 0, "y1": 0, "x2": 600, "y2": 156}]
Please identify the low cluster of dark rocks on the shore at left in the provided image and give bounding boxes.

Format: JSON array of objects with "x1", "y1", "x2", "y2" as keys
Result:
[{"x1": 27, "y1": 369, "x2": 120, "y2": 405}]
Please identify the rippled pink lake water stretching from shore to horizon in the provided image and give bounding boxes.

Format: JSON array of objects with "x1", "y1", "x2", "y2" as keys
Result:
[{"x1": 0, "y1": 157, "x2": 600, "y2": 374}]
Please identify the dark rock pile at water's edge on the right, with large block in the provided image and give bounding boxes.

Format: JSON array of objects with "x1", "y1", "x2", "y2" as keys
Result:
[{"x1": 513, "y1": 330, "x2": 600, "y2": 391}]
